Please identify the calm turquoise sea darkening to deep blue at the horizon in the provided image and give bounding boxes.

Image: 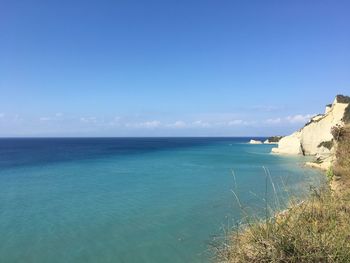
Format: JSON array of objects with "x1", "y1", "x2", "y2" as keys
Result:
[{"x1": 0, "y1": 138, "x2": 320, "y2": 263}]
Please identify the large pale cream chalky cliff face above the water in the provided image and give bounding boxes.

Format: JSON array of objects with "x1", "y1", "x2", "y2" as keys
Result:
[{"x1": 272, "y1": 96, "x2": 350, "y2": 159}]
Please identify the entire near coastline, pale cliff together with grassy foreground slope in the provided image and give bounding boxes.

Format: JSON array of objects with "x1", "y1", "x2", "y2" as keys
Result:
[{"x1": 217, "y1": 96, "x2": 350, "y2": 263}]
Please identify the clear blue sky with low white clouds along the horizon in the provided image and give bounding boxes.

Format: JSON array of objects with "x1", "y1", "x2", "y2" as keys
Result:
[{"x1": 0, "y1": 0, "x2": 350, "y2": 137}]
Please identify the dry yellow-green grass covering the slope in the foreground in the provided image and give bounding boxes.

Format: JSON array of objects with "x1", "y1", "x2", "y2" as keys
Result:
[{"x1": 216, "y1": 125, "x2": 350, "y2": 263}]
